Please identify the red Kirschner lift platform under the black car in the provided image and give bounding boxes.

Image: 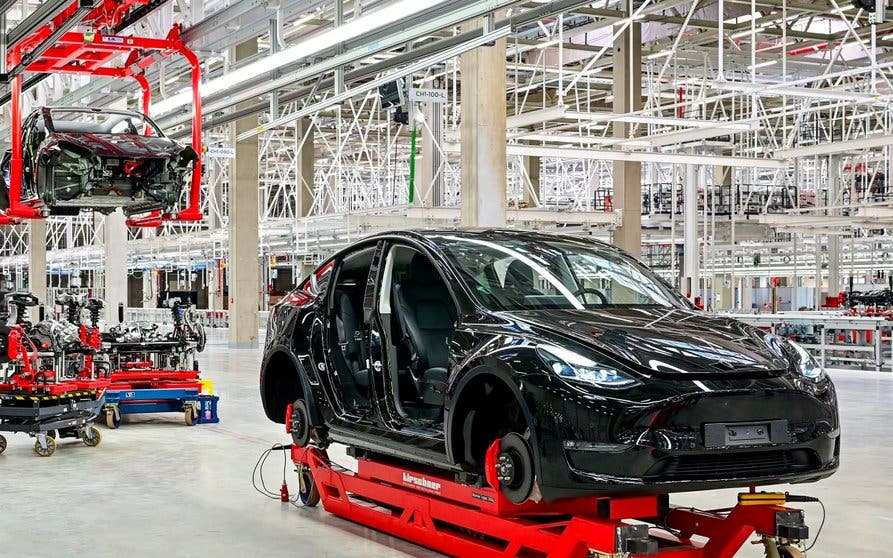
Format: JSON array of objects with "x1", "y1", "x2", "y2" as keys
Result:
[{"x1": 291, "y1": 443, "x2": 812, "y2": 558}]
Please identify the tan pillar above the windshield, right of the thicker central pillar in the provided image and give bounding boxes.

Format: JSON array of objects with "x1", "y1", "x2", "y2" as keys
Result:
[{"x1": 613, "y1": 7, "x2": 642, "y2": 256}]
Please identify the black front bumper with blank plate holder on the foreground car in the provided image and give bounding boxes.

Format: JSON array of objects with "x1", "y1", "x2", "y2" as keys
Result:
[{"x1": 529, "y1": 379, "x2": 840, "y2": 499}]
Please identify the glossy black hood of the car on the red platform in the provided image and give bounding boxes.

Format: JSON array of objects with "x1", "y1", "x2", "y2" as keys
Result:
[{"x1": 511, "y1": 307, "x2": 790, "y2": 377}]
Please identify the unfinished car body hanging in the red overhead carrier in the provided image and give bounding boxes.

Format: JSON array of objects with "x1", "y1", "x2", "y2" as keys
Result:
[{"x1": 0, "y1": 107, "x2": 197, "y2": 215}]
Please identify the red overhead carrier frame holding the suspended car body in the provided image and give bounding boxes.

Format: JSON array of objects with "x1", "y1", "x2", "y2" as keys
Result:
[{"x1": 0, "y1": 0, "x2": 202, "y2": 227}]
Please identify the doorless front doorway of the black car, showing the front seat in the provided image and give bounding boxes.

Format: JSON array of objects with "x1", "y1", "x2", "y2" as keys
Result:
[{"x1": 380, "y1": 245, "x2": 457, "y2": 423}]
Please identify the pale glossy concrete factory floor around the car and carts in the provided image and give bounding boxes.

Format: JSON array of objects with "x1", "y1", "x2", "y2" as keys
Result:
[{"x1": 0, "y1": 331, "x2": 893, "y2": 558}]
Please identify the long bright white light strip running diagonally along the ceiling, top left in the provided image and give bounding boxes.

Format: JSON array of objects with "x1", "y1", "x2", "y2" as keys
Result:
[{"x1": 151, "y1": 0, "x2": 447, "y2": 117}]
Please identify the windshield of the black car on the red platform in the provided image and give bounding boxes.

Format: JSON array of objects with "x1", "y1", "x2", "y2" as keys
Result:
[{"x1": 431, "y1": 235, "x2": 683, "y2": 311}]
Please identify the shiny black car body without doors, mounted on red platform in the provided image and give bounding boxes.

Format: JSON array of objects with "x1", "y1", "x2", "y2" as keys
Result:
[{"x1": 260, "y1": 230, "x2": 839, "y2": 499}]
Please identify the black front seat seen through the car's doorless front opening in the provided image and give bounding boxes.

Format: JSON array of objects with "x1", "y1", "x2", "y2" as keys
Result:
[{"x1": 394, "y1": 254, "x2": 456, "y2": 406}]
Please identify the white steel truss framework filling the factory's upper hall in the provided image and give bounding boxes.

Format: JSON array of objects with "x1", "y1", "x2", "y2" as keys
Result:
[{"x1": 0, "y1": 0, "x2": 893, "y2": 294}]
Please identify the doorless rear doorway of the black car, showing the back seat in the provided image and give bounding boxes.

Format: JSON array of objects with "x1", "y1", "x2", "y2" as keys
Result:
[{"x1": 329, "y1": 247, "x2": 375, "y2": 411}]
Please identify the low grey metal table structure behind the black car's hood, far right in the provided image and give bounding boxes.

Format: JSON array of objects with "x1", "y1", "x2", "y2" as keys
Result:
[{"x1": 726, "y1": 312, "x2": 893, "y2": 372}]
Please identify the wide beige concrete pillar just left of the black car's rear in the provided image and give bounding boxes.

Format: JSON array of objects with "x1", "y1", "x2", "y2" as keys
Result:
[{"x1": 227, "y1": 39, "x2": 261, "y2": 348}]
